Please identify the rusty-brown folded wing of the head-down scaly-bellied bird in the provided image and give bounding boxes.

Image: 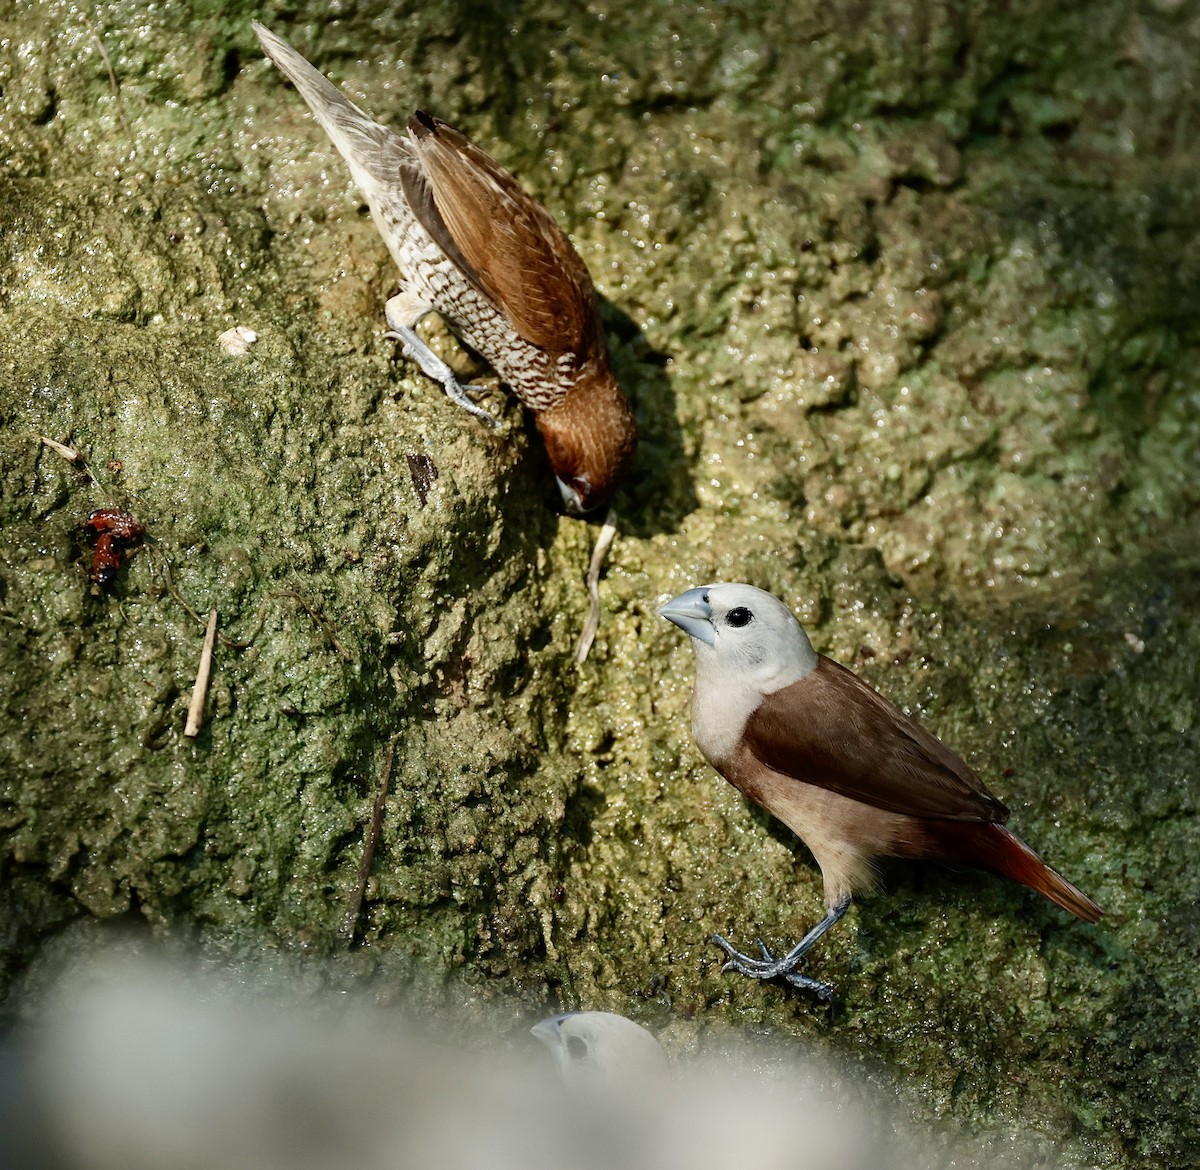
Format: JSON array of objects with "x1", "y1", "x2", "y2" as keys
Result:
[{"x1": 401, "y1": 110, "x2": 596, "y2": 353}]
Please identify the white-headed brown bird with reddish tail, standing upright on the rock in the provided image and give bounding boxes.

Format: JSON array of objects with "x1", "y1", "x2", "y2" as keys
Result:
[{"x1": 659, "y1": 584, "x2": 1102, "y2": 998}]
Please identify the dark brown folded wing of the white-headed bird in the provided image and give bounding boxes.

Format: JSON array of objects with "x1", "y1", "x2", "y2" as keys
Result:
[{"x1": 744, "y1": 656, "x2": 1008, "y2": 823}]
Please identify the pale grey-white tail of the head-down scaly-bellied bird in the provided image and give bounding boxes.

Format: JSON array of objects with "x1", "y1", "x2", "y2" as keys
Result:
[{"x1": 253, "y1": 20, "x2": 412, "y2": 184}]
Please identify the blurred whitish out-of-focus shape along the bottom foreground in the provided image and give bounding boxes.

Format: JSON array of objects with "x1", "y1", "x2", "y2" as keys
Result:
[{"x1": 0, "y1": 959, "x2": 896, "y2": 1170}]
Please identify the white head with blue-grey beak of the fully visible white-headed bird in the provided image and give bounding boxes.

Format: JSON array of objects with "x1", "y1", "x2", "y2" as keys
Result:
[{"x1": 659, "y1": 584, "x2": 817, "y2": 695}]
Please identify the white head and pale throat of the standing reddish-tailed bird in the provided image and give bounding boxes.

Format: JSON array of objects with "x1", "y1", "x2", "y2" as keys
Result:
[{"x1": 659, "y1": 584, "x2": 817, "y2": 768}]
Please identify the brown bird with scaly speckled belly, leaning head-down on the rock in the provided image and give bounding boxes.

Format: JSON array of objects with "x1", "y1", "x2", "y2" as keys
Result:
[{"x1": 254, "y1": 22, "x2": 637, "y2": 515}]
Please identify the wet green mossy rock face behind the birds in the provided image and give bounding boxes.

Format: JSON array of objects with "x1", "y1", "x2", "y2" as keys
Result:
[{"x1": 0, "y1": 0, "x2": 1200, "y2": 1166}]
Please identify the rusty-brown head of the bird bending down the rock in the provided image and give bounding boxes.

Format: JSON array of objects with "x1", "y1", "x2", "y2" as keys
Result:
[{"x1": 535, "y1": 368, "x2": 637, "y2": 516}]
